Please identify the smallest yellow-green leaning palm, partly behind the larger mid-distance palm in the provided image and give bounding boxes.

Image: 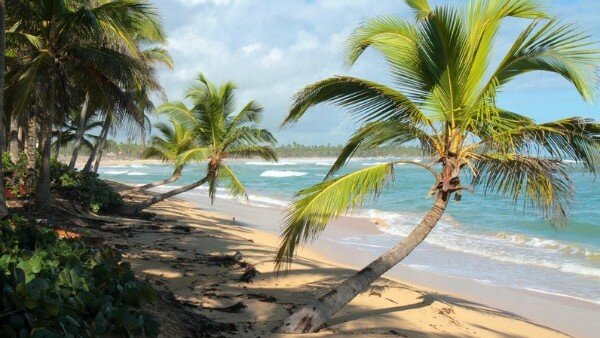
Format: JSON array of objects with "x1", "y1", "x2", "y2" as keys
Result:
[{"x1": 123, "y1": 119, "x2": 196, "y2": 195}]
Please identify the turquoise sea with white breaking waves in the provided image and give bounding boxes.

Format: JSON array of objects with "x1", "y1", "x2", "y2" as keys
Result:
[{"x1": 99, "y1": 159, "x2": 600, "y2": 303}]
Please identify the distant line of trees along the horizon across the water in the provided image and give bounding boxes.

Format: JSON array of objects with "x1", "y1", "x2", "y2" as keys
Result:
[{"x1": 61, "y1": 140, "x2": 421, "y2": 159}]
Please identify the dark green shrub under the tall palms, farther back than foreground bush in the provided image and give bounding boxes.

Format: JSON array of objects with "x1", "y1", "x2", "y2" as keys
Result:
[{"x1": 50, "y1": 161, "x2": 123, "y2": 213}]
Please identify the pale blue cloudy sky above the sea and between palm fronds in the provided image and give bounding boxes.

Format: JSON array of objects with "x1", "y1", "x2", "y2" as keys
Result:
[{"x1": 146, "y1": 0, "x2": 600, "y2": 145}]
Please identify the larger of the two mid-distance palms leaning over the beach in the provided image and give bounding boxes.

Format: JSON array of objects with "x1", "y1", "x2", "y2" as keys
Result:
[{"x1": 123, "y1": 74, "x2": 277, "y2": 215}]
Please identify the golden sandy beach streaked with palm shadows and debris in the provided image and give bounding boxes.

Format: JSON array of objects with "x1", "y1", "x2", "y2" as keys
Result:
[{"x1": 63, "y1": 185, "x2": 598, "y2": 337}]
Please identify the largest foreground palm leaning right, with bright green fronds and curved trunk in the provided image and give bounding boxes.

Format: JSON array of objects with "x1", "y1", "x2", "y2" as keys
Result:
[{"x1": 277, "y1": 0, "x2": 600, "y2": 333}]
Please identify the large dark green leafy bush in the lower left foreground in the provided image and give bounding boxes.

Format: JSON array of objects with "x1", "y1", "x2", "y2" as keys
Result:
[{"x1": 0, "y1": 218, "x2": 159, "y2": 338}]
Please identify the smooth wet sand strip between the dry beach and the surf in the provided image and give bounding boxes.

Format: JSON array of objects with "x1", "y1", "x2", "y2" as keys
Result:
[{"x1": 145, "y1": 185, "x2": 600, "y2": 338}]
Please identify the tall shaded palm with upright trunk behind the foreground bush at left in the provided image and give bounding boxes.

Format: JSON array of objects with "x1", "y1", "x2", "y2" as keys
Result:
[{"x1": 7, "y1": 0, "x2": 162, "y2": 211}]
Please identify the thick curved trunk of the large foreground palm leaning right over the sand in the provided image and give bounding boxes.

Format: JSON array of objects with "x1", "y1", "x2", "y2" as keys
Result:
[{"x1": 280, "y1": 192, "x2": 449, "y2": 333}]
